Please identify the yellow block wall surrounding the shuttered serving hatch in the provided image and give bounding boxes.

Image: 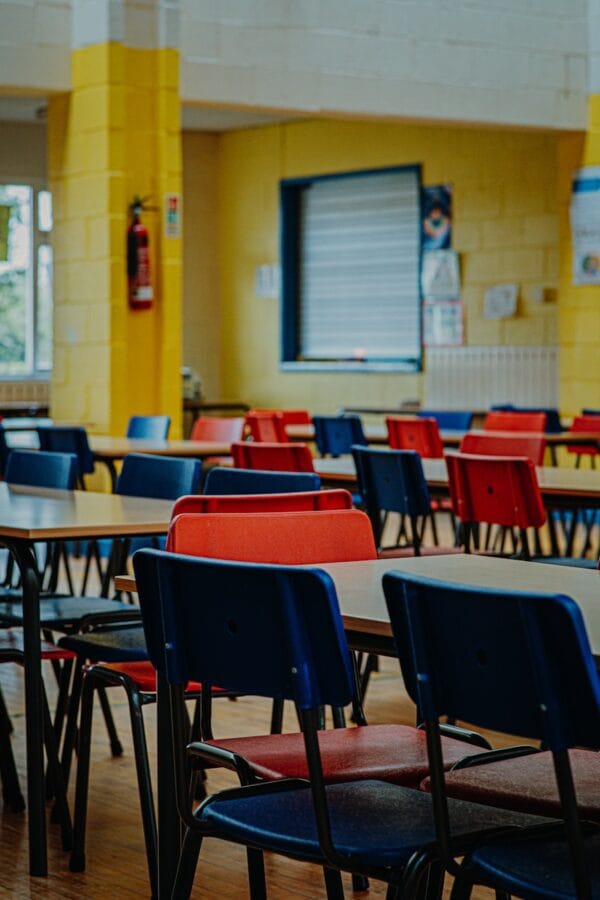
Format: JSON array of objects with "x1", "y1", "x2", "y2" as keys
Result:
[{"x1": 213, "y1": 120, "x2": 558, "y2": 411}]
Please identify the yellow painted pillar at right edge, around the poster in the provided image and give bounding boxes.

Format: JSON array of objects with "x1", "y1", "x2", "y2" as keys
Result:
[{"x1": 558, "y1": 101, "x2": 600, "y2": 416}]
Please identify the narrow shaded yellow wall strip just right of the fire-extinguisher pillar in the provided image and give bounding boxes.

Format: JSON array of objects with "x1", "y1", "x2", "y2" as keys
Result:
[{"x1": 183, "y1": 131, "x2": 221, "y2": 400}]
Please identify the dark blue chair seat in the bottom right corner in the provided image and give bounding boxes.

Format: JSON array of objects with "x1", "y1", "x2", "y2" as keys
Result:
[{"x1": 467, "y1": 833, "x2": 600, "y2": 900}]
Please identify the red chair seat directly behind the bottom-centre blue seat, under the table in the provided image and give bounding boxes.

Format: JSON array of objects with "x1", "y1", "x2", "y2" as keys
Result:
[{"x1": 207, "y1": 725, "x2": 486, "y2": 787}]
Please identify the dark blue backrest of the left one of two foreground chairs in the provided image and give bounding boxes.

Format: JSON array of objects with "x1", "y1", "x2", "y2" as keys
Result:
[{"x1": 133, "y1": 550, "x2": 353, "y2": 709}]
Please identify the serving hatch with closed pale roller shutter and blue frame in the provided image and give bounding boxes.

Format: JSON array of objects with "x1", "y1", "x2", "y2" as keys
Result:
[{"x1": 280, "y1": 166, "x2": 421, "y2": 372}]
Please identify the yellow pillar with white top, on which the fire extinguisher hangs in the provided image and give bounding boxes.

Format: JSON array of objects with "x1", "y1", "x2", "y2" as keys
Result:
[{"x1": 48, "y1": 0, "x2": 182, "y2": 436}]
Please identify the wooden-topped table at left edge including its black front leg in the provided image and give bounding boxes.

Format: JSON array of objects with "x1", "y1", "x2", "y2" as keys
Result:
[{"x1": 0, "y1": 482, "x2": 173, "y2": 875}]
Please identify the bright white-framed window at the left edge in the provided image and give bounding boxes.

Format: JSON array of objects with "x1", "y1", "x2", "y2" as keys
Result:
[{"x1": 0, "y1": 184, "x2": 53, "y2": 378}]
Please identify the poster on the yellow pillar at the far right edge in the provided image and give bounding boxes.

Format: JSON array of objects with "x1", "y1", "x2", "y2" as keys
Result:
[{"x1": 571, "y1": 166, "x2": 600, "y2": 284}]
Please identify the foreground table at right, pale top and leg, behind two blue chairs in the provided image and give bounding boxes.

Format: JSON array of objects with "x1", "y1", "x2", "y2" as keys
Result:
[{"x1": 116, "y1": 554, "x2": 600, "y2": 900}]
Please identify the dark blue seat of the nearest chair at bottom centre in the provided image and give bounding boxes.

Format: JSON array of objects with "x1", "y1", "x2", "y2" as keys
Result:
[{"x1": 196, "y1": 781, "x2": 547, "y2": 867}]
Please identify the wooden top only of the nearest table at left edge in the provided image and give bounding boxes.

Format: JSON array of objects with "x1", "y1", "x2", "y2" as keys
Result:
[{"x1": 0, "y1": 482, "x2": 173, "y2": 541}]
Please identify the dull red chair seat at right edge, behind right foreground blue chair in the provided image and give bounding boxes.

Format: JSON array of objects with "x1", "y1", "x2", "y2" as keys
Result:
[{"x1": 423, "y1": 750, "x2": 600, "y2": 823}]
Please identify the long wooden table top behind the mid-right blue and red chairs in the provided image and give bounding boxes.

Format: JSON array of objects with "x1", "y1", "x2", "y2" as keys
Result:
[{"x1": 314, "y1": 456, "x2": 600, "y2": 503}]
